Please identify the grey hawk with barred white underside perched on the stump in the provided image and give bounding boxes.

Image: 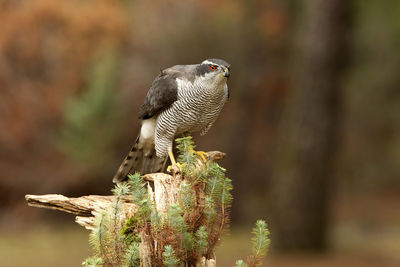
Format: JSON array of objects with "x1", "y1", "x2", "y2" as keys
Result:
[{"x1": 113, "y1": 59, "x2": 230, "y2": 183}]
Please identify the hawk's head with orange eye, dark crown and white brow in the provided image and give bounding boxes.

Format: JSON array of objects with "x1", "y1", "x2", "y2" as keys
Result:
[{"x1": 196, "y1": 58, "x2": 230, "y2": 83}]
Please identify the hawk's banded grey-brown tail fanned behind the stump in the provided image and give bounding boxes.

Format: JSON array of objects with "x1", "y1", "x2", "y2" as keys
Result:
[{"x1": 113, "y1": 134, "x2": 167, "y2": 183}]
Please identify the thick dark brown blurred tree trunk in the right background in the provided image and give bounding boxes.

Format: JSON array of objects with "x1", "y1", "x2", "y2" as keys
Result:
[{"x1": 269, "y1": 0, "x2": 350, "y2": 251}]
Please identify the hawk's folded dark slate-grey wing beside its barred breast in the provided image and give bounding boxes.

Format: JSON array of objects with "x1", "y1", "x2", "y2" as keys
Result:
[{"x1": 139, "y1": 66, "x2": 182, "y2": 120}]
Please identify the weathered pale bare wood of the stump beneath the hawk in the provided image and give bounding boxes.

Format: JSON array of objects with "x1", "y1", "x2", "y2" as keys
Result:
[{"x1": 25, "y1": 151, "x2": 225, "y2": 267}]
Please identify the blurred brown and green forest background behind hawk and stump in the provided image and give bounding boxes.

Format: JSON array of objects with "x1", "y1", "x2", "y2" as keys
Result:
[{"x1": 0, "y1": 0, "x2": 400, "y2": 266}]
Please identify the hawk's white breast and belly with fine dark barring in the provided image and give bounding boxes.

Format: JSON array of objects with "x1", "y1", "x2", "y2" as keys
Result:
[{"x1": 154, "y1": 79, "x2": 228, "y2": 157}]
